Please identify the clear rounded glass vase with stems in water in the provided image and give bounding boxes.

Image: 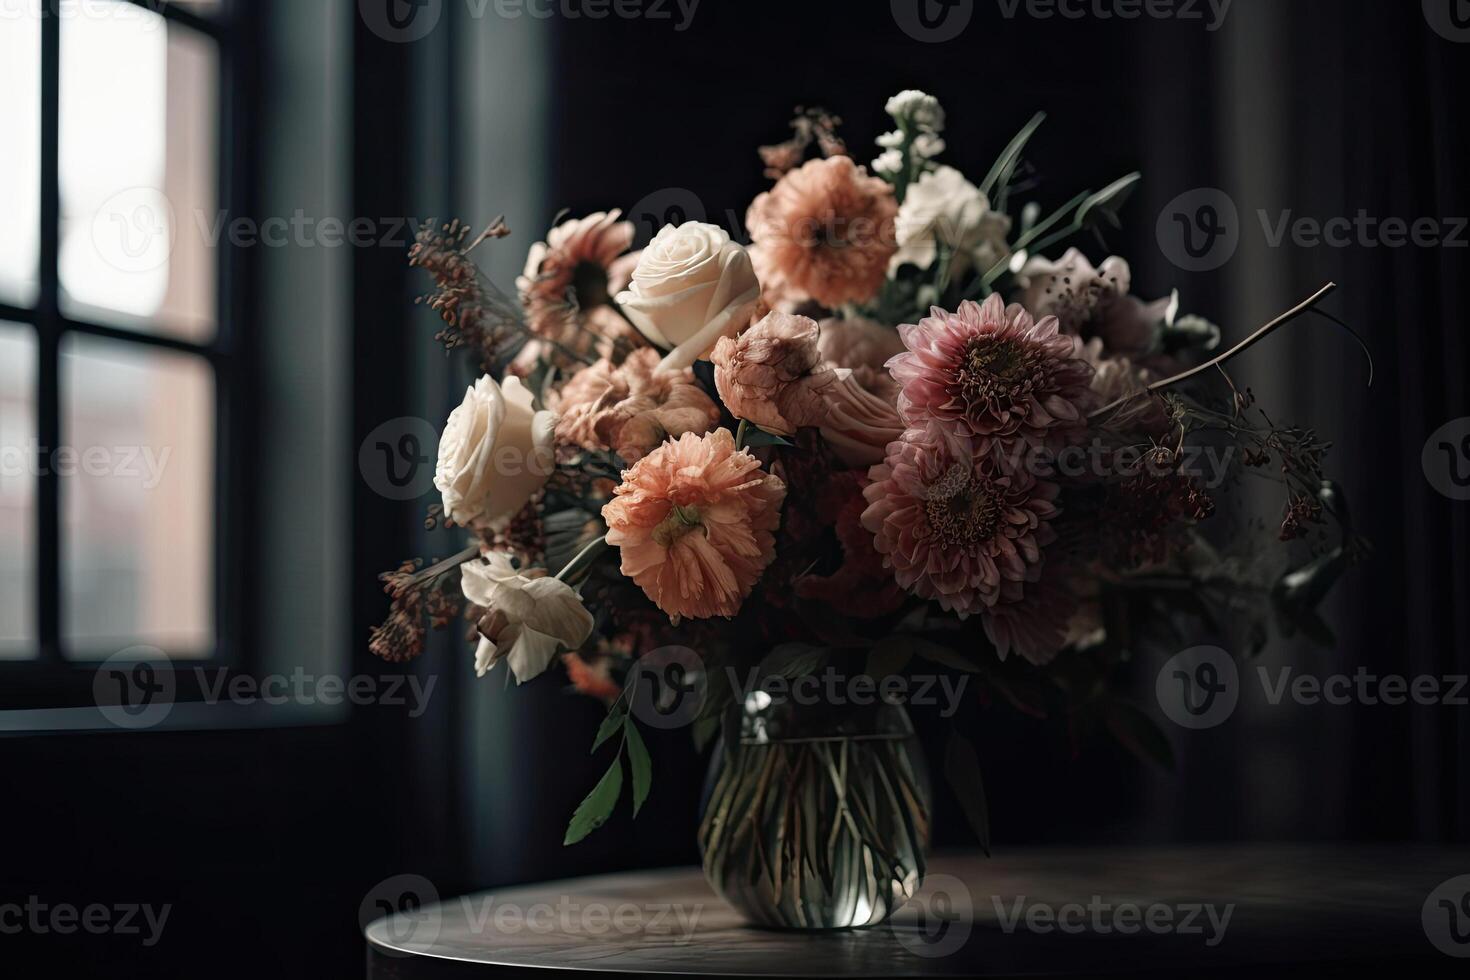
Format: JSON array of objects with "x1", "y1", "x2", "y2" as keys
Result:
[{"x1": 700, "y1": 691, "x2": 931, "y2": 930}]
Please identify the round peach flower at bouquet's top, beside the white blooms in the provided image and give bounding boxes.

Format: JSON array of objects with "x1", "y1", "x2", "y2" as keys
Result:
[{"x1": 745, "y1": 156, "x2": 898, "y2": 309}]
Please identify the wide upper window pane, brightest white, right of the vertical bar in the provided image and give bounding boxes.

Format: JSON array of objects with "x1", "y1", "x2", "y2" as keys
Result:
[{"x1": 60, "y1": 0, "x2": 222, "y2": 341}]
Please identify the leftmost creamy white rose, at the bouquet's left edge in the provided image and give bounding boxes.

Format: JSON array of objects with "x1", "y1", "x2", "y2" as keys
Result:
[{"x1": 434, "y1": 375, "x2": 557, "y2": 526}]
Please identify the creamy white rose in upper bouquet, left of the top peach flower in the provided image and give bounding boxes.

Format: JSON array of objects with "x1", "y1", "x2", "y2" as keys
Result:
[{"x1": 617, "y1": 222, "x2": 760, "y2": 370}]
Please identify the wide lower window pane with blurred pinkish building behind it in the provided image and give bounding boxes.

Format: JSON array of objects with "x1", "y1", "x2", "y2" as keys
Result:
[{"x1": 57, "y1": 334, "x2": 215, "y2": 658}]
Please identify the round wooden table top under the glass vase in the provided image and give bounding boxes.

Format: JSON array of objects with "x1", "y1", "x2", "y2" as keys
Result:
[{"x1": 366, "y1": 845, "x2": 1470, "y2": 980}]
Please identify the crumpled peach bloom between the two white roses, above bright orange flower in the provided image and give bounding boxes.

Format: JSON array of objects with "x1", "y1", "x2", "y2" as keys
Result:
[{"x1": 556, "y1": 347, "x2": 720, "y2": 464}]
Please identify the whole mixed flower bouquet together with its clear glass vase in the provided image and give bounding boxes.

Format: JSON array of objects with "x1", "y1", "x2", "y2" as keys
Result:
[{"x1": 370, "y1": 91, "x2": 1366, "y2": 929}]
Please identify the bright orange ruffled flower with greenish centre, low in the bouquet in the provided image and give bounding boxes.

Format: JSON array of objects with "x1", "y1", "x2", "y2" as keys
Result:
[{"x1": 603, "y1": 429, "x2": 786, "y2": 624}]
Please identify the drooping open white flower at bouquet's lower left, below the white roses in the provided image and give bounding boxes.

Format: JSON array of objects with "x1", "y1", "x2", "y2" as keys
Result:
[{"x1": 460, "y1": 552, "x2": 592, "y2": 683}]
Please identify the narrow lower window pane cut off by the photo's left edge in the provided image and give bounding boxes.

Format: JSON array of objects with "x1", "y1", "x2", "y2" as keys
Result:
[{"x1": 0, "y1": 323, "x2": 37, "y2": 660}]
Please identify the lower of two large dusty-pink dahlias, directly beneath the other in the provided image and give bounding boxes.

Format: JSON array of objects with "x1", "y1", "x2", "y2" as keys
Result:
[{"x1": 863, "y1": 423, "x2": 1058, "y2": 619}]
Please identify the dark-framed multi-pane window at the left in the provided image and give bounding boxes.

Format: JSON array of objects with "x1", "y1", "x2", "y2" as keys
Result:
[{"x1": 0, "y1": 0, "x2": 250, "y2": 693}]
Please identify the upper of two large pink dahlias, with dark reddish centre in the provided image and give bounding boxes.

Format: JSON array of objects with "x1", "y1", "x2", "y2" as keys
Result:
[{"x1": 888, "y1": 295, "x2": 1097, "y2": 453}]
